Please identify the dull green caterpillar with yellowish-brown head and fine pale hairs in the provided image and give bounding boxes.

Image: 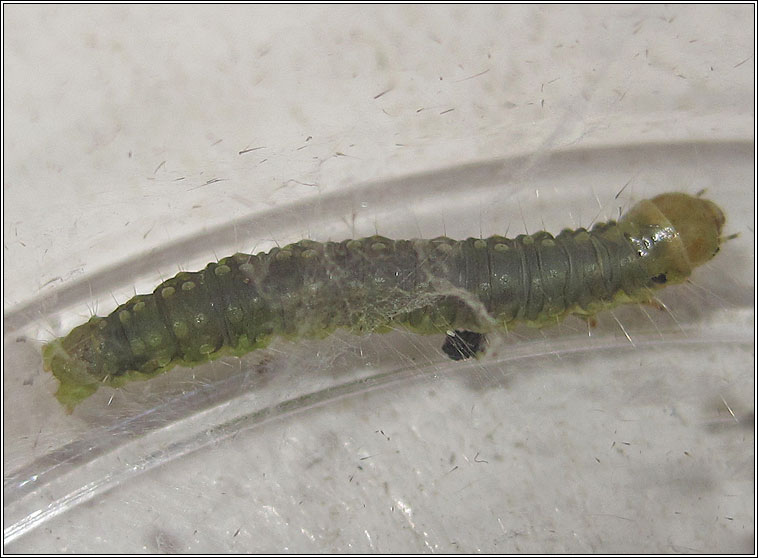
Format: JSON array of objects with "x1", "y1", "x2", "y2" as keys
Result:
[{"x1": 43, "y1": 193, "x2": 725, "y2": 412}]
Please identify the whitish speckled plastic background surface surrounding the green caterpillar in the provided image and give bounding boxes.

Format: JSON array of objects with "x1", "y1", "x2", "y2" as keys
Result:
[{"x1": 3, "y1": 5, "x2": 755, "y2": 552}]
